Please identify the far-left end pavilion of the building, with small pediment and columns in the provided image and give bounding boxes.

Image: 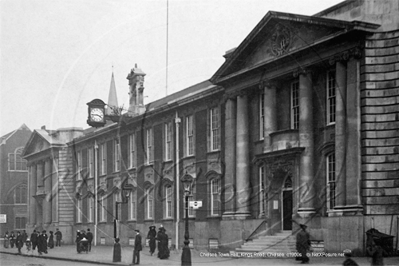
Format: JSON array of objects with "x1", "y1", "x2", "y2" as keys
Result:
[{"x1": 24, "y1": 127, "x2": 82, "y2": 244}]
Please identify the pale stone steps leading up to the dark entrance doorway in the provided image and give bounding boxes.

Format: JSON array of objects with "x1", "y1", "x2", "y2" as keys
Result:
[{"x1": 236, "y1": 232, "x2": 296, "y2": 257}]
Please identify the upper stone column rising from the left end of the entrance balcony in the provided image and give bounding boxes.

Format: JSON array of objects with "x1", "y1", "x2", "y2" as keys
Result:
[{"x1": 263, "y1": 83, "x2": 277, "y2": 152}]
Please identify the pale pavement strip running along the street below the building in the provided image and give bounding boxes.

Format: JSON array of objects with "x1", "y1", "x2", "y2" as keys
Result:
[{"x1": 0, "y1": 245, "x2": 399, "y2": 266}]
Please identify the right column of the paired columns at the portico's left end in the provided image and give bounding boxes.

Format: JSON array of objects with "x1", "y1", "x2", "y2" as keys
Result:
[{"x1": 235, "y1": 94, "x2": 250, "y2": 219}]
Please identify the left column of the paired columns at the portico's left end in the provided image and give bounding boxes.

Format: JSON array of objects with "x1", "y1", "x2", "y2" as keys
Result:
[{"x1": 223, "y1": 99, "x2": 237, "y2": 218}]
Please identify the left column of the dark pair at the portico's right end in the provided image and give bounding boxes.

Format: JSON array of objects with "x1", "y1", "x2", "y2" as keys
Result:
[{"x1": 335, "y1": 61, "x2": 347, "y2": 208}]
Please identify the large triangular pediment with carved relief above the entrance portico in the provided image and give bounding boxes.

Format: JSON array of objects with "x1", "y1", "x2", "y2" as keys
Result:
[{"x1": 211, "y1": 12, "x2": 379, "y2": 84}]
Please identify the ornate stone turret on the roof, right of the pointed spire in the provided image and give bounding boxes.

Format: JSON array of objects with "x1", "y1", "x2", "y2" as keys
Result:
[{"x1": 127, "y1": 64, "x2": 146, "y2": 116}]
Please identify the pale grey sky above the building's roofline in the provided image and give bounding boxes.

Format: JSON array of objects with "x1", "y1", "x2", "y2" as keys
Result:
[{"x1": 0, "y1": 0, "x2": 342, "y2": 136}]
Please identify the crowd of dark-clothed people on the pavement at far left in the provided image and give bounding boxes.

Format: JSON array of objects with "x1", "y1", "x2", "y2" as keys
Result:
[{"x1": 4, "y1": 228, "x2": 62, "y2": 255}]
